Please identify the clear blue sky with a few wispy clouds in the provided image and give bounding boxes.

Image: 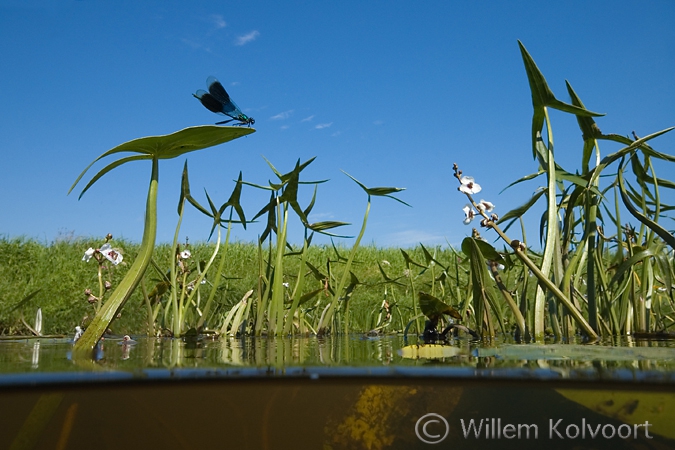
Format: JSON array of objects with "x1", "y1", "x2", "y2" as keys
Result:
[{"x1": 0, "y1": 0, "x2": 675, "y2": 247}]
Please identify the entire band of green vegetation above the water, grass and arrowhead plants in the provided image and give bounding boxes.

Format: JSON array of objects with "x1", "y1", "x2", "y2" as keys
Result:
[{"x1": 5, "y1": 42, "x2": 675, "y2": 348}]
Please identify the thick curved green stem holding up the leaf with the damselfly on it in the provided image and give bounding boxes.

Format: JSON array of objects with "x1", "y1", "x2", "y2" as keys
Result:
[{"x1": 73, "y1": 157, "x2": 159, "y2": 359}]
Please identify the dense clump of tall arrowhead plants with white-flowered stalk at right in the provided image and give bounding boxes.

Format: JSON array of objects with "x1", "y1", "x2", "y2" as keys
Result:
[{"x1": 454, "y1": 42, "x2": 675, "y2": 340}]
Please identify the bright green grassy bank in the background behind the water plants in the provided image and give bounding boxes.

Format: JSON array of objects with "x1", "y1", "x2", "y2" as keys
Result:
[{"x1": 0, "y1": 237, "x2": 466, "y2": 335}]
